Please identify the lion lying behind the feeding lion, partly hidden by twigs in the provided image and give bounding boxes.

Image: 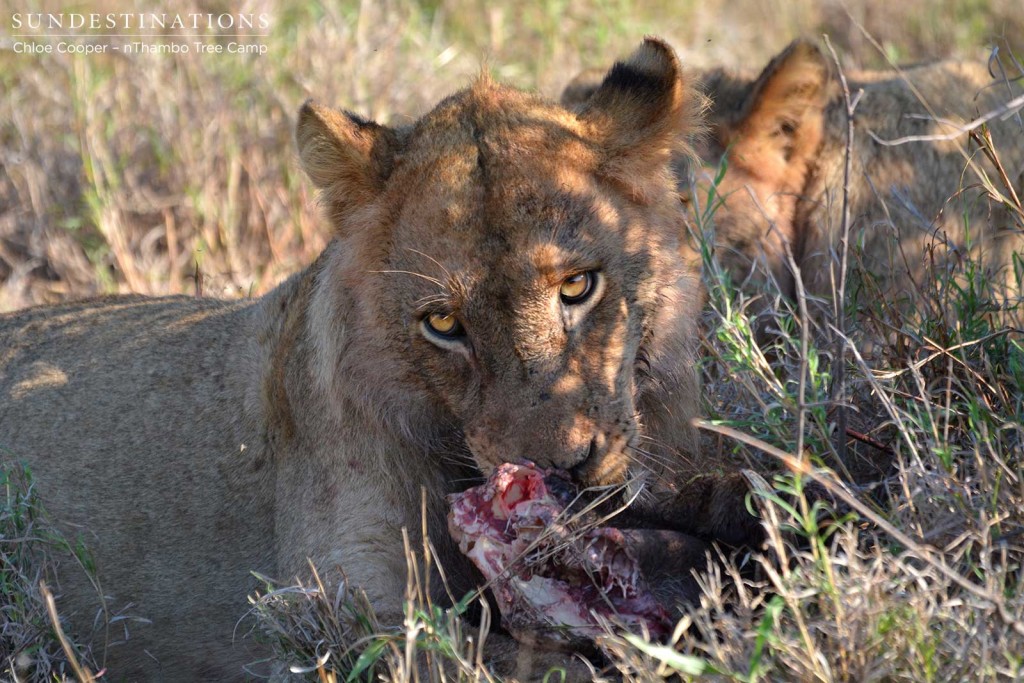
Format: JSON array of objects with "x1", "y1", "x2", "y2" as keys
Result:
[{"x1": 562, "y1": 40, "x2": 1024, "y2": 321}]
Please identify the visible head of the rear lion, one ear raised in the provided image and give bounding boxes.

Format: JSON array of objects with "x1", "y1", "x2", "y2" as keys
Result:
[{"x1": 681, "y1": 40, "x2": 831, "y2": 297}]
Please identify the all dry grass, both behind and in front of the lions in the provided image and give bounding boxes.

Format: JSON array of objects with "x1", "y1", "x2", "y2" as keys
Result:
[{"x1": 0, "y1": 0, "x2": 1024, "y2": 681}]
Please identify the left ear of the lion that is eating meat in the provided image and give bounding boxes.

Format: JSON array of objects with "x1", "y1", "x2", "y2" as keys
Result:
[{"x1": 295, "y1": 100, "x2": 396, "y2": 218}]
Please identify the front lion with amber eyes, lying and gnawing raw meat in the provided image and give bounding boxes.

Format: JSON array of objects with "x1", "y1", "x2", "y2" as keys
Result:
[{"x1": 0, "y1": 38, "x2": 758, "y2": 680}]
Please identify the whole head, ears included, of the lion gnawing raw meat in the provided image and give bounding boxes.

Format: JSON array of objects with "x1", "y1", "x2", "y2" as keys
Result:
[{"x1": 299, "y1": 37, "x2": 693, "y2": 484}]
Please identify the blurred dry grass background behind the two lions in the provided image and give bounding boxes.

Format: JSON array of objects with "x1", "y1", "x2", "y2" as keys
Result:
[{"x1": 0, "y1": 0, "x2": 1024, "y2": 311}]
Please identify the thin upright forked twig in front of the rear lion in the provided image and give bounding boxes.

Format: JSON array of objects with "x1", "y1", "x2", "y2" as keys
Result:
[{"x1": 824, "y1": 35, "x2": 864, "y2": 469}]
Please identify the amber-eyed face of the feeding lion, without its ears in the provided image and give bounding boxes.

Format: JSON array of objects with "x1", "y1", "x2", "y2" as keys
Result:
[{"x1": 382, "y1": 152, "x2": 680, "y2": 489}]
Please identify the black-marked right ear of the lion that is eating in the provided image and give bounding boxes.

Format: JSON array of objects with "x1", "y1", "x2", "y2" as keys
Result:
[{"x1": 577, "y1": 37, "x2": 702, "y2": 189}]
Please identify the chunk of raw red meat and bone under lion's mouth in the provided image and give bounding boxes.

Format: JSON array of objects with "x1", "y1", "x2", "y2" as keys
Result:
[{"x1": 449, "y1": 464, "x2": 673, "y2": 646}]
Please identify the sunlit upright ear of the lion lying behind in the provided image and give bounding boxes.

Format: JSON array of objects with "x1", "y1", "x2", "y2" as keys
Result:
[{"x1": 734, "y1": 40, "x2": 831, "y2": 172}]
